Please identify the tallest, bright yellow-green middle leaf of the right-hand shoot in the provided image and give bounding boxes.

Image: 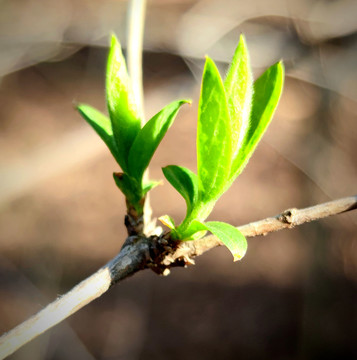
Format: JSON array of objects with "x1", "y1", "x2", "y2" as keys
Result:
[{"x1": 224, "y1": 35, "x2": 253, "y2": 157}]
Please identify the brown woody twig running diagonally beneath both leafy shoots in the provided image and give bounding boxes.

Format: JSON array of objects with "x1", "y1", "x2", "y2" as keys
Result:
[{"x1": 0, "y1": 195, "x2": 357, "y2": 359}]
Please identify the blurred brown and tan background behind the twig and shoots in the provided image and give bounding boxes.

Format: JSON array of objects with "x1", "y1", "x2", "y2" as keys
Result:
[{"x1": 0, "y1": 0, "x2": 357, "y2": 360}]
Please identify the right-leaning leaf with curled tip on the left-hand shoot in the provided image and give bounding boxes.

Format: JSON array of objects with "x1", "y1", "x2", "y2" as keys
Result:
[{"x1": 128, "y1": 100, "x2": 189, "y2": 182}]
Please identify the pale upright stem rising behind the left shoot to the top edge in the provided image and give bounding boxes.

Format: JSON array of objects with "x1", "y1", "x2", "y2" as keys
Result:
[{"x1": 128, "y1": 0, "x2": 146, "y2": 125}]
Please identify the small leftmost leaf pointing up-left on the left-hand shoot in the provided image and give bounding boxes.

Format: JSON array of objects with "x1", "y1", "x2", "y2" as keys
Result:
[{"x1": 77, "y1": 104, "x2": 120, "y2": 165}]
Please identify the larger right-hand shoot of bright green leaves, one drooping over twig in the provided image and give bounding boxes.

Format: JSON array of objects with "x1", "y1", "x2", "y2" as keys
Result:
[{"x1": 160, "y1": 36, "x2": 284, "y2": 260}]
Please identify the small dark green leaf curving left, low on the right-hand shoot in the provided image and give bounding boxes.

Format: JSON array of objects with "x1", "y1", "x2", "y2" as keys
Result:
[{"x1": 162, "y1": 165, "x2": 198, "y2": 217}]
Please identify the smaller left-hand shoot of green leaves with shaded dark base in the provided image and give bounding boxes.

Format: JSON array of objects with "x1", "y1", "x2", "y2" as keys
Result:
[{"x1": 77, "y1": 35, "x2": 189, "y2": 214}]
